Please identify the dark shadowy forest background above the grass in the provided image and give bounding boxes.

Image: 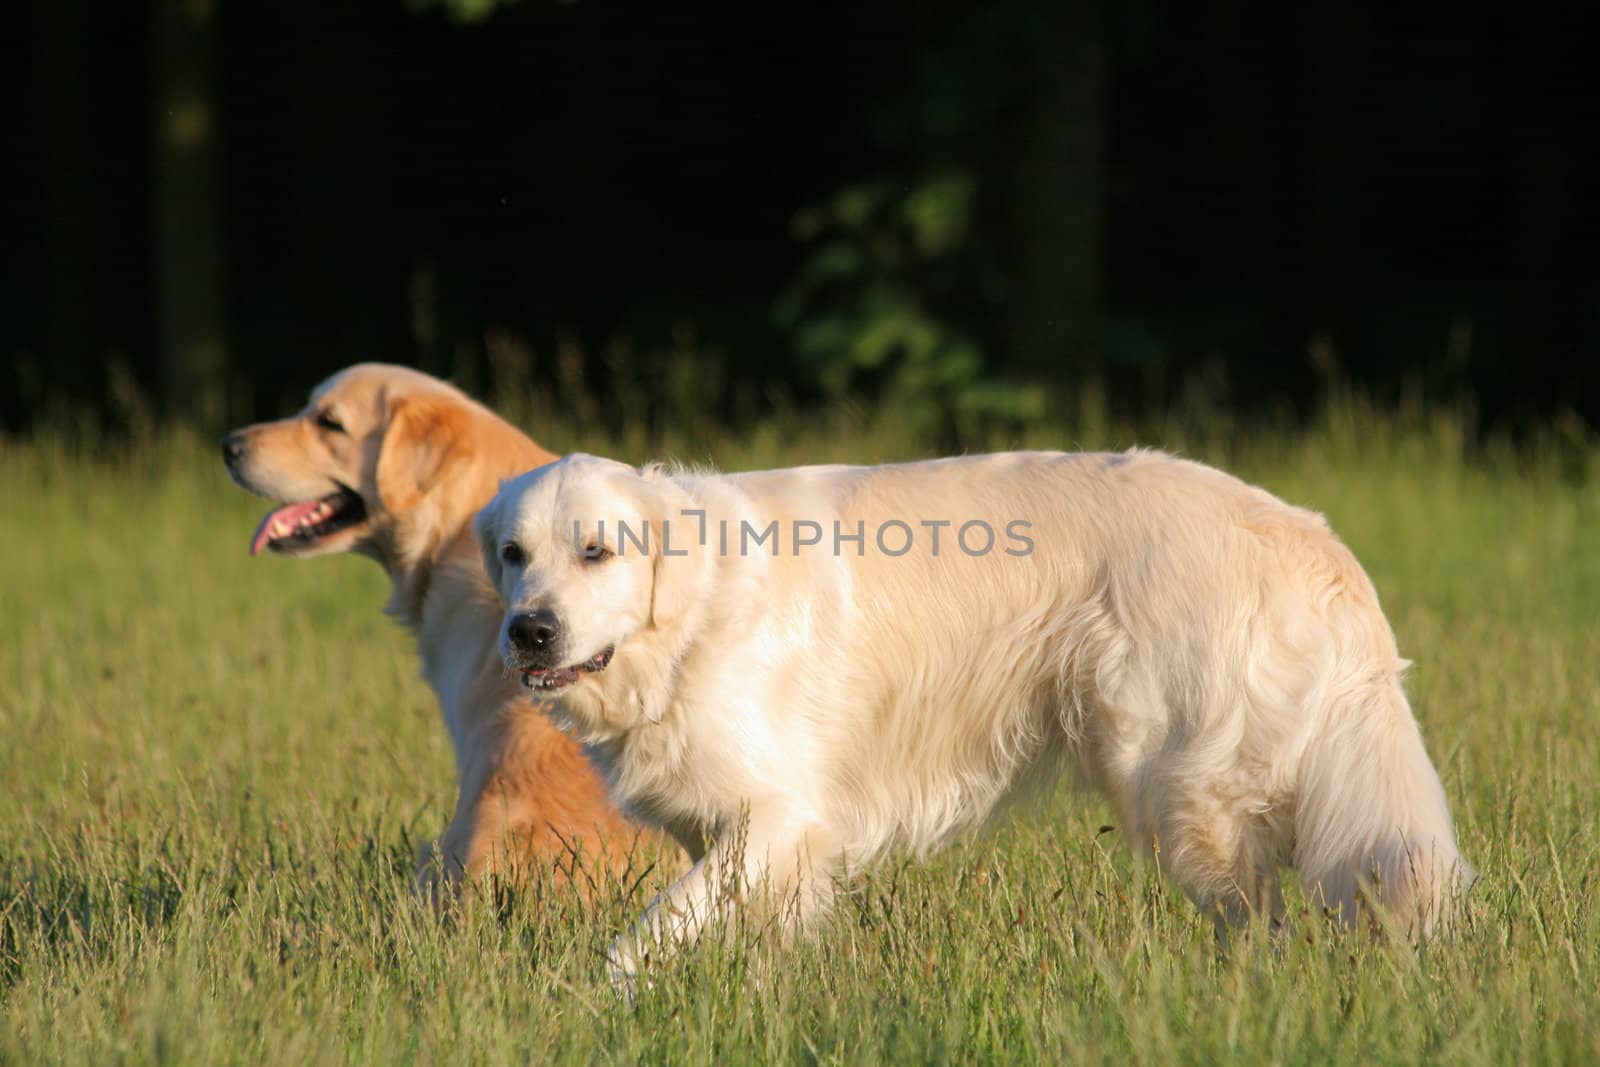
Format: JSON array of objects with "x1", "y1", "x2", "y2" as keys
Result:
[{"x1": 0, "y1": 0, "x2": 1600, "y2": 441}]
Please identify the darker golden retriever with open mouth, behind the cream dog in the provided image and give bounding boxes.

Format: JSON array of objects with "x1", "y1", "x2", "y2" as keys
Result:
[{"x1": 222, "y1": 363, "x2": 662, "y2": 888}]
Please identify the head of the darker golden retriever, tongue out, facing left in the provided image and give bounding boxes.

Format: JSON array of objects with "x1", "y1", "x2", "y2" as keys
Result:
[{"x1": 222, "y1": 363, "x2": 531, "y2": 566}]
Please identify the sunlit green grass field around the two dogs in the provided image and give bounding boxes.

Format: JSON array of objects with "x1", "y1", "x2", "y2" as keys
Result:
[{"x1": 0, "y1": 402, "x2": 1600, "y2": 1064}]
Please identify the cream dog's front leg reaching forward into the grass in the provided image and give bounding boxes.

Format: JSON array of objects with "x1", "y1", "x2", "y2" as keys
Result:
[{"x1": 606, "y1": 817, "x2": 832, "y2": 997}]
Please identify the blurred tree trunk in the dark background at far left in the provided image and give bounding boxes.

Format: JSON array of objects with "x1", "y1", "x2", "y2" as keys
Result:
[{"x1": 150, "y1": 0, "x2": 227, "y2": 429}]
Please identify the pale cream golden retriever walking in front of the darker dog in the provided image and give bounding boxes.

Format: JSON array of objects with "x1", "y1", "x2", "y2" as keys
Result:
[{"x1": 478, "y1": 451, "x2": 1467, "y2": 982}]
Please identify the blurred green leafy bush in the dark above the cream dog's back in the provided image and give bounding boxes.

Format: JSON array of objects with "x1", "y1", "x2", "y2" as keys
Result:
[{"x1": 776, "y1": 174, "x2": 1045, "y2": 438}]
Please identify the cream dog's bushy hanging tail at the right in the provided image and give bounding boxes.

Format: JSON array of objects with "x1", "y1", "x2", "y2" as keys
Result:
[{"x1": 1294, "y1": 680, "x2": 1477, "y2": 937}]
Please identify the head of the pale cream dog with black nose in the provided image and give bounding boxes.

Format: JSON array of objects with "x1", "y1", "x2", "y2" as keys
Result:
[{"x1": 477, "y1": 453, "x2": 698, "y2": 694}]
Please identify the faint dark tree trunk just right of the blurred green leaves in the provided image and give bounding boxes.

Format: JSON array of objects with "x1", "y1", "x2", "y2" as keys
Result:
[{"x1": 1010, "y1": 0, "x2": 1107, "y2": 376}]
